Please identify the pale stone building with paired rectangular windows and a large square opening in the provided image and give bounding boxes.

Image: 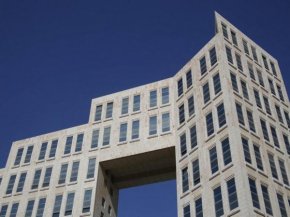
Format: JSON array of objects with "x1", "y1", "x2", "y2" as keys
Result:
[{"x1": 0, "y1": 13, "x2": 290, "y2": 217}]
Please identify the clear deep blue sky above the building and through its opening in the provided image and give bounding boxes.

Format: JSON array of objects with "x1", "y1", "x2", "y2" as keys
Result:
[{"x1": 0, "y1": 0, "x2": 290, "y2": 217}]
